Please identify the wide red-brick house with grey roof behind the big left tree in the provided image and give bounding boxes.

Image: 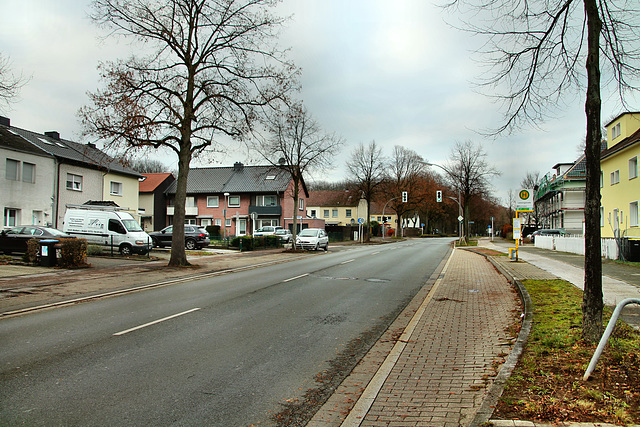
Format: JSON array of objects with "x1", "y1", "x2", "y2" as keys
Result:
[{"x1": 165, "y1": 162, "x2": 309, "y2": 236}]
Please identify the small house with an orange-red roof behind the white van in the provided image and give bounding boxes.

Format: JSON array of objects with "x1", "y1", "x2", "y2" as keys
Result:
[{"x1": 138, "y1": 173, "x2": 175, "y2": 231}]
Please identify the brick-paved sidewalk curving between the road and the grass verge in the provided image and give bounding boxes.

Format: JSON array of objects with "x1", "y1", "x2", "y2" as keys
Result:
[{"x1": 309, "y1": 250, "x2": 520, "y2": 427}]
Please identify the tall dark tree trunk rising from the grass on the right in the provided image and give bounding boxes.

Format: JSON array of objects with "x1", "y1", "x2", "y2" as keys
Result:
[{"x1": 582, "y1": 0, "x2": 603, "y2": 342}]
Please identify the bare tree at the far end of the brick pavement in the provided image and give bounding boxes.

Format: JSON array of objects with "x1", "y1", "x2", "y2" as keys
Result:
[{"x1": 445, "y1": 141, "x2": 500, "y2": 240}]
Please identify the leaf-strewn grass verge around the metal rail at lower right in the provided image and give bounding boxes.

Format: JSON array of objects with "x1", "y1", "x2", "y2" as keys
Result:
[{"x1": 494, "y1": 280, "x2": 640, "y2": 425}]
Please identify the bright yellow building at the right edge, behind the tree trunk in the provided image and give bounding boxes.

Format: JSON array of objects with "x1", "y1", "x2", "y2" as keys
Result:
[{"x1": 600, "y1": 112, "x2": 640, "y2": 237}]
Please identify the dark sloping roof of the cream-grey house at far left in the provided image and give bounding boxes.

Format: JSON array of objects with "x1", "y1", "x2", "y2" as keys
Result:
[{"x1": 0, "y1": 122, "x2": 142, "y2": 178}]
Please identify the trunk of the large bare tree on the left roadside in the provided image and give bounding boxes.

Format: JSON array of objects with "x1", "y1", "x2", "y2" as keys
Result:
[{"x1": 169, "y1": 142, "x2": 191, "y2": 267}]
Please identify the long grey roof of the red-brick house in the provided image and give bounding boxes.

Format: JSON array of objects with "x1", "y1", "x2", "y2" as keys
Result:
[{"x1": 166, "y1": 163, "x2": 291, "y2": 194}]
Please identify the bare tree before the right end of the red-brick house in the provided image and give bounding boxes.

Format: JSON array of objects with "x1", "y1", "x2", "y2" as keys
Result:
[{"x1": 252, "y1": 104, "x2": 344, "y2": 248}]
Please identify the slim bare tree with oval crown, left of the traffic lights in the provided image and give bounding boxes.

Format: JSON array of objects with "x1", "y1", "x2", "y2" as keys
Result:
[{"x1": 347, "y1": 141, "x2": 386, "y2": 241}]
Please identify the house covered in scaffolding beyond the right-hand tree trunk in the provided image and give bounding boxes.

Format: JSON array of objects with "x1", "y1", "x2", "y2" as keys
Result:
[{"x1": 534, "y1": 155, "x2": 586, "y2": 234}]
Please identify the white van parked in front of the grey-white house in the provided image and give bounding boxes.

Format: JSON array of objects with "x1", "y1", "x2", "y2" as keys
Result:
[{"x1": 63, "y1": 206, "x2": 153, "y2": 255}]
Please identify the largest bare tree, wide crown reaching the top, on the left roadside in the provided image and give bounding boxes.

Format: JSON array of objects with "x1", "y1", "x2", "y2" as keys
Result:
[{"x1": 80, "y1": 0, "x2": 298, "y2": 266}]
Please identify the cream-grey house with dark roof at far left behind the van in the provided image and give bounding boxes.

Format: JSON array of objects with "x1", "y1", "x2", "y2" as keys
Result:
[{"x1": 0, "y1": 117, "x2": 142, "y2": 228}]
